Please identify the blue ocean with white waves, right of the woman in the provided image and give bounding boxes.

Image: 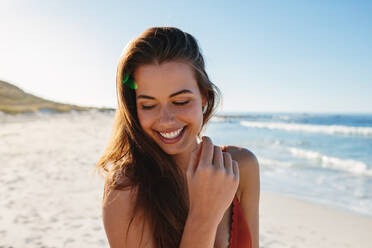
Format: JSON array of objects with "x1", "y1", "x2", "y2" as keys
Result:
[{"x1": 205, "y1": 113, "x2": 372, "y2": 216}]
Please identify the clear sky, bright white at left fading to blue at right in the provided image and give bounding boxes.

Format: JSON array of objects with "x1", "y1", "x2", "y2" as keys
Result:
[{"x1": 0, "y1": 0, "x2": 372, "y2": 113}]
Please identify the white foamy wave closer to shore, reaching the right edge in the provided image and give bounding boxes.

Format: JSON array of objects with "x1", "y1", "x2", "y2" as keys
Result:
[{"x1": 288, "y1": 147, "x2": 372, "y2": 176}]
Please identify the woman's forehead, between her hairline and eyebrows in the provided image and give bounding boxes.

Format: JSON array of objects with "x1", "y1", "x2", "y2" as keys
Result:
[{"x1": 134, "y1": 61, "x2": 198, "y2": 97}]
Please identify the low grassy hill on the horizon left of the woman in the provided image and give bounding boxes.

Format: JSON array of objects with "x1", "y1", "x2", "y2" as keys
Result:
[{"x1": 0, "y1": 80, "x2": 114, "y2": 114}]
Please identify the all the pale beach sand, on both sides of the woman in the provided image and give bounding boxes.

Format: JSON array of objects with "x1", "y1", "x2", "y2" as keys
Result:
[{"x1": 0, "y1": 112, "x2": 372, "y2": 248}]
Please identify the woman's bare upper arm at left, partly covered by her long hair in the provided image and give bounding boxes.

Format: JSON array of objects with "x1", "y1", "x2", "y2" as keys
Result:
[{"x1": 102, "y1": 174, "x2": 153, "y2": 248}]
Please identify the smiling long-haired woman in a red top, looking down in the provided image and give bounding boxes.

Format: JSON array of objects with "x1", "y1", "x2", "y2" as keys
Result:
[{"x1": 97, "y1": 27, "x2": 260, "y2": 248}]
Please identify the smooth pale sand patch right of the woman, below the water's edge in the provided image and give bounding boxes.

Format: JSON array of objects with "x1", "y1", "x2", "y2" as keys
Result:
[{"x1": 260, "y1": 192, "x2": 372, "y2": 248}]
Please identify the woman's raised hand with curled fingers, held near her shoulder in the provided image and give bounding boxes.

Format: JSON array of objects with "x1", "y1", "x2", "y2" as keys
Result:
[{"x1": 186, "y1": 136, "x2": 239, "y2": 224}]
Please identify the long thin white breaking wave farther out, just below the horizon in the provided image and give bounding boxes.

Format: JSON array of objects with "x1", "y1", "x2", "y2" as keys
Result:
[{"x1": 240, "y1": 121, "x2": 372, "y2": 136}]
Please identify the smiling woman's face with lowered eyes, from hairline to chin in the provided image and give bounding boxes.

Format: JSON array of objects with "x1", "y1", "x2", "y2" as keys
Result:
[{"x1": 134, "y1": 61, "x2": 206, "y2": 155}]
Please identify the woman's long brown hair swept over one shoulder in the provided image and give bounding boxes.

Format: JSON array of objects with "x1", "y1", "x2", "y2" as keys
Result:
[{"x1": 95, "y1": 27, "x2": 221, "y2": 248}]
